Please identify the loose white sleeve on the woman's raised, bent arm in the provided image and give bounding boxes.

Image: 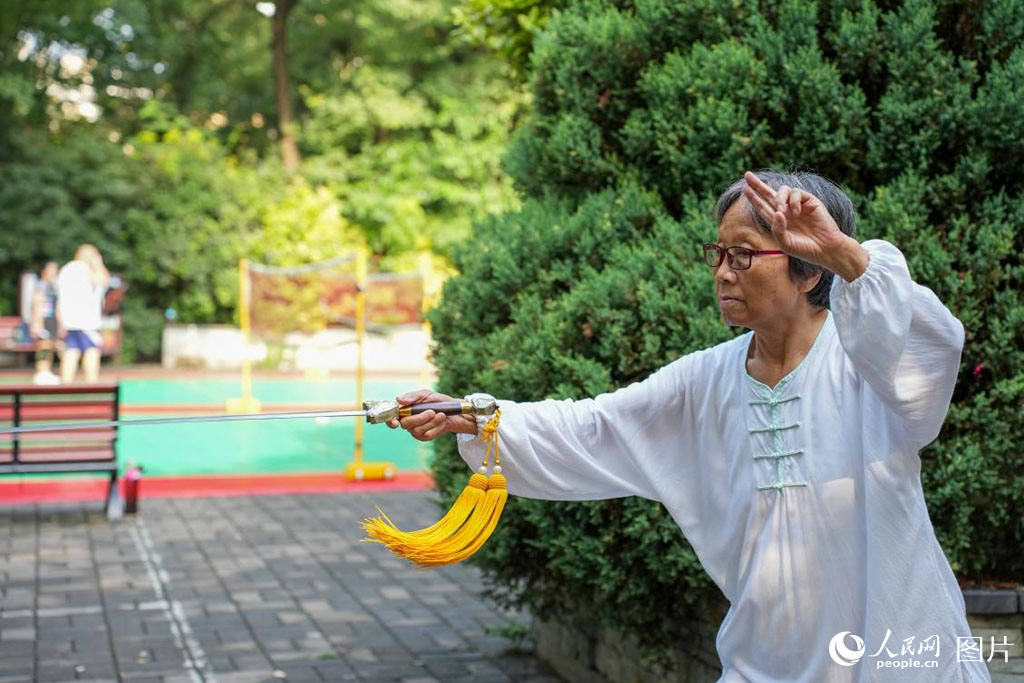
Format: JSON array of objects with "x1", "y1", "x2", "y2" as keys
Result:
[{"x1": 831, "y1": 240, "x2": 964, "y2": 447}]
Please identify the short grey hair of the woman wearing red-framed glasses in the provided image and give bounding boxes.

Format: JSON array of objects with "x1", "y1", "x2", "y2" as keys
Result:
[{"x1": 713, "y1": 170, "x2": 857, "y2": 308}]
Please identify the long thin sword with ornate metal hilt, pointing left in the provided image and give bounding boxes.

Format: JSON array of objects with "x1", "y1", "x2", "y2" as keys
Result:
[{"x1": 0, "y1": 397, "x2": 498, "y2": 439}]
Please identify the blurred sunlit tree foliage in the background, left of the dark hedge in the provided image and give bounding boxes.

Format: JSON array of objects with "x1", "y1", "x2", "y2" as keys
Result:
[{"x1": 0, "y1": 0, "x2": 522, "y2": 357}]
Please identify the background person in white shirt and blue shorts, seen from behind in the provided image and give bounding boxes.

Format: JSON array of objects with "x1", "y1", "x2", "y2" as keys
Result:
[{"x1": 57, "y1": 245, "x2": 111, "y2": 384}]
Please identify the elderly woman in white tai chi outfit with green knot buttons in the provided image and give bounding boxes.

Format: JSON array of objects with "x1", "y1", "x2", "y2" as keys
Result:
[{"x1": 391, "y1": 172, "x2": 989, "y2": 683}]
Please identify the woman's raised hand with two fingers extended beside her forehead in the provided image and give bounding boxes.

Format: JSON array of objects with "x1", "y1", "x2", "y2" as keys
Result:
[{"x1": 743, "y1": 171, "x2": 868, "y2": 282}]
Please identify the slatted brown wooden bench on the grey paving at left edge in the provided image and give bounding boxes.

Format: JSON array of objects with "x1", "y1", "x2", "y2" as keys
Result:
[{"x1": 0, "y1": 383, "x2": 123, "y2": 519}]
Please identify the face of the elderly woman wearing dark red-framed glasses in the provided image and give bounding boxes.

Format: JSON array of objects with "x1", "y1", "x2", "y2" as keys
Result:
[{"x1": 715, "y1": 198, "x2": 817, "y2": 330}]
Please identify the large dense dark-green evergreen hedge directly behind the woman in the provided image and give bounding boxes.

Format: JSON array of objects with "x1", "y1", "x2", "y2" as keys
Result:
[{"x1": 431, "y1": 0, "x2": 1024, "y2": 663}]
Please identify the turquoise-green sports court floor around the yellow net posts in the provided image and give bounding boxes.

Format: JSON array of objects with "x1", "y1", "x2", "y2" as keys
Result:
[{"x1": 0, "y1": 371, "x2": 429, "y2": 477}]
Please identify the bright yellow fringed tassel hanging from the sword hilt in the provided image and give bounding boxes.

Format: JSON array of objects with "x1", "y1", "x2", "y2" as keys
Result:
[{"x1": 362, "y1": 411, "x2": 508, "y2": 567}]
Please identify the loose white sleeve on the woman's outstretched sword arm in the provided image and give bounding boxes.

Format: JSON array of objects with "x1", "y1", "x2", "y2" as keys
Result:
[{"x1": 459, "y1": 357, "x2": 685, "y2": 501}]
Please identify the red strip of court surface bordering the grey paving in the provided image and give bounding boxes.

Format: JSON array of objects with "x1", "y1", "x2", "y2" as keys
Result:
[{"x1": 0, "y1": 472, "x2": 434, "y2": 505}]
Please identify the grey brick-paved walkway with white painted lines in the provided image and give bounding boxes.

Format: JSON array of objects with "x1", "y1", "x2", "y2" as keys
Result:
[{"x1": 0, "y1": 493, "x2": 559, "y2": 683}]
